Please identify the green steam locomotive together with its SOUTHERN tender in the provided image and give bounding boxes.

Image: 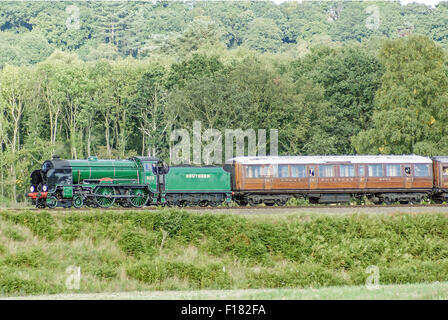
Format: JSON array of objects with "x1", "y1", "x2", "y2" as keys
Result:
[{"x1": 27, "y1": 156, "x2": 232, "y2": 208}]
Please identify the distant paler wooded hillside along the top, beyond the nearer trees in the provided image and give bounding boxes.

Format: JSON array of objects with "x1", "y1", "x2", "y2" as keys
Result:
[{"x1": 0, "y1": 0, "x2": 448, "y2": 66}]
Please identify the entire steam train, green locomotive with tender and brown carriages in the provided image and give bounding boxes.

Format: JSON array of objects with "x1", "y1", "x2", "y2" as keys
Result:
[{"x1": 27, "y1": 155, "x2": 448, "y2": 208}]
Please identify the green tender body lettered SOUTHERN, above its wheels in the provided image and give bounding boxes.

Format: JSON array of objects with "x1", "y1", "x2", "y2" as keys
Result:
[{"x1": 165, "y1": 166, "x2": 231, "y2": 193}]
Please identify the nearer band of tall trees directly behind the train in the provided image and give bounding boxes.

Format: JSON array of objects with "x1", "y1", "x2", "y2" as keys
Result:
[{"x1": 0, "y1": 36, "x2": 448, "y2": 201}]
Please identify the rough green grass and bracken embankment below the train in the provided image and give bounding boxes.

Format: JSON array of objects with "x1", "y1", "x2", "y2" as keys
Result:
[{"x1": 0, "y1": 209, "x2": 448, "y2": 298}]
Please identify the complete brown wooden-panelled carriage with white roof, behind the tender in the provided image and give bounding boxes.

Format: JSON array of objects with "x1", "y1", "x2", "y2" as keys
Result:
[{"x1": 226, "y1": 155, "x2": 434, "y2": 205}]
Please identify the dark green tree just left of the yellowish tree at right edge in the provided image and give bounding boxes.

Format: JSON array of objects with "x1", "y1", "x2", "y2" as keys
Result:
[{"x1": 292, "y1": 46, "x2": 382, "y2": 154}]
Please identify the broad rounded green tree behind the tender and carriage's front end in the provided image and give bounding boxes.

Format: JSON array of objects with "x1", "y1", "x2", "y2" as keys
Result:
[{"x1": 166, "y1": 56, "x2": 305, "y2": 159}]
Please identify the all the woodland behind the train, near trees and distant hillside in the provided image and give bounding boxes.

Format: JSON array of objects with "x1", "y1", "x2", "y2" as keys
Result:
[{"x1": 0, "y1": 1, "x2": 448, "y2": 202}]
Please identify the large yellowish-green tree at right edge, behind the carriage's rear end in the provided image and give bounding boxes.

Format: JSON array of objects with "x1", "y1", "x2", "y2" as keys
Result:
[{"x1": 353, "y1": 36, "x2": 448, "y2": 155}]
